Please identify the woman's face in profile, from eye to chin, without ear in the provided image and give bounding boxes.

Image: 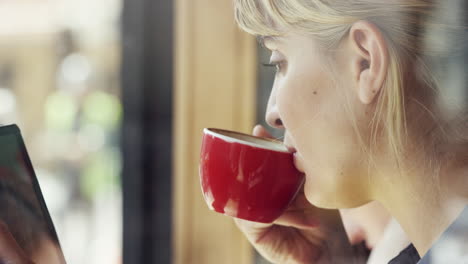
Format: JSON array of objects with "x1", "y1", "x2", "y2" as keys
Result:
[{"x1": 264, "y1": 33, "x2": 370, "y2": 208}]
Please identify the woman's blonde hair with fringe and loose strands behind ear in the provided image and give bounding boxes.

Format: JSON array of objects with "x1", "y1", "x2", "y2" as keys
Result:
[{"x1": 235, "y1": 0, "x2": 464, "y2": 177}]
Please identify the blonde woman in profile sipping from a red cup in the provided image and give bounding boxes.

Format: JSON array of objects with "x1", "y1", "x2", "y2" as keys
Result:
[{"x1": 235, "y1": 0, "x2": 468, "y2": 263}]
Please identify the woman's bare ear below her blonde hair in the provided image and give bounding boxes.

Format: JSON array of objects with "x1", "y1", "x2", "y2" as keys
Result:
[{"x1": 348, "y1": 21, "x2": 389, "y2": 104}]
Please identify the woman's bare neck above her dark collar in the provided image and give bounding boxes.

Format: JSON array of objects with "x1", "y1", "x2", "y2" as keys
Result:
[{"x1": 375, "y1": 102, "x2": 468, "y2": 256}]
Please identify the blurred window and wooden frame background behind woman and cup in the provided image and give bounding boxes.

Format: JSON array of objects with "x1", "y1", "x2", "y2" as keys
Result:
[{"x1": 0, "y1": 0, "x2": 468, "y2": 264}]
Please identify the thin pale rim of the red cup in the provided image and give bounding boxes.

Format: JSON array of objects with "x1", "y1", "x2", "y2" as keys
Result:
[{"x1": 203, "y1": 128, "x2": 291, "y2": 154}]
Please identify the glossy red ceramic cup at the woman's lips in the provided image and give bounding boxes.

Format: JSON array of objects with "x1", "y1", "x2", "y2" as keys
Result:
[{"x1": 200, "y1": 128, "x2": 304, "y2": 223}]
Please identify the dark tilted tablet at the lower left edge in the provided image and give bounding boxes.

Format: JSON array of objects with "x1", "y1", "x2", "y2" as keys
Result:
[{"x1": 0, "y1": 125, "x2": 66, "y2": 264}]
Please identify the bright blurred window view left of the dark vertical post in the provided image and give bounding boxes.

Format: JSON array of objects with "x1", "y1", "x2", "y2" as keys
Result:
[{"x1": 0, "y1": 0, "x2": 122, "y2": 263}]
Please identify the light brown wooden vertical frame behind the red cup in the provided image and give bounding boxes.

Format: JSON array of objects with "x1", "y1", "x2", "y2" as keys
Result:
[{"x1": 172, "y1": 0, "x2": 256, "y2": 264}]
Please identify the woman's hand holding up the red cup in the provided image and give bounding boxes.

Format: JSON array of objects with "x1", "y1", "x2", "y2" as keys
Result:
[{"x1": 201, "y1": 126, "x2": 365, "y2": 264}]
